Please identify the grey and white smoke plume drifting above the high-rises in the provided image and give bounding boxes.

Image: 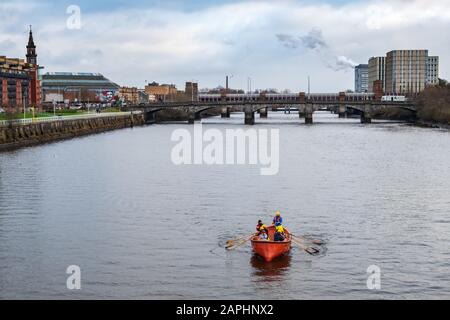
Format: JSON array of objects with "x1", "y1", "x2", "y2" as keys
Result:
[{"x1": 276, "y1": 28, "x2": 357, "y2": 72}]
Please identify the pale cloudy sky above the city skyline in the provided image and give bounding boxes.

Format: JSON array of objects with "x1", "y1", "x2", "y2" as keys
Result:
[{"x1": 0, "y1": 0, "x2": 450, "y2": 92}]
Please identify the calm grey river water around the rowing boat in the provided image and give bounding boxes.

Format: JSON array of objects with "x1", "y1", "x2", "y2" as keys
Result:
[{"x1": 0, "y1": 113, "x2": 450, "y2": 299}]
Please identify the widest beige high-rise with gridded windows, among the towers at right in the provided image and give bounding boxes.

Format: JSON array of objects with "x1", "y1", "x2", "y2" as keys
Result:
[{"x1": 385, "y1": 50, "x2": 428, "y2": 95}]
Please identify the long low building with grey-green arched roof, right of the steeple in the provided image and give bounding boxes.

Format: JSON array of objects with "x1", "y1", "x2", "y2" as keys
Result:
[{"x1": 42, "y1": 72, "x2": 120, "y2": 103}]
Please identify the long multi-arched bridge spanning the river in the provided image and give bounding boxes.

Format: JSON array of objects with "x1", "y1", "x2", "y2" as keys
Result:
[{"x1": 127, "y1": 92, "x2": 416, "y2": 125}]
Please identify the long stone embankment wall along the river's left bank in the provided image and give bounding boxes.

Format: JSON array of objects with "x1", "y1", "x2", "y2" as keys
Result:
[{"x1": 0, "y1": 114, "x2": 145, "y2": 152}]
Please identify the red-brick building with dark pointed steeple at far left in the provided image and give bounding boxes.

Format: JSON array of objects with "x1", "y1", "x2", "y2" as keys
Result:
[{"x1": 0, "y1": 29, "x2": 41, "y2": 112}]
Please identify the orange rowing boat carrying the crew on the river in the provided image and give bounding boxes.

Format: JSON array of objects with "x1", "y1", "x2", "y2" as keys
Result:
[{"x1": 251, "y1": 226, "x2": 292, "y2": 262}]
